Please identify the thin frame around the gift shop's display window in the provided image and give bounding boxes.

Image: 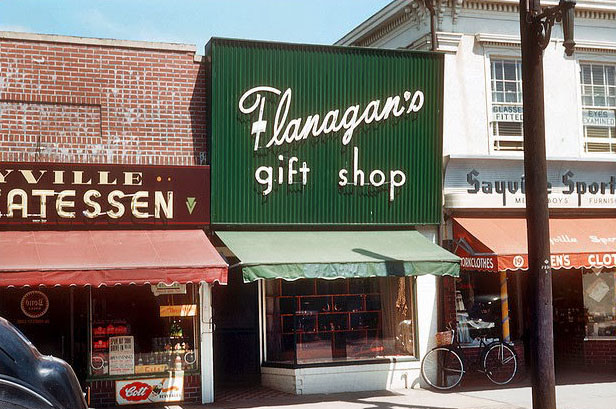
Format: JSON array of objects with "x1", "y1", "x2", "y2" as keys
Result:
[{"x1": 260, "y1": 276, "x2": 420, "y2": 369}]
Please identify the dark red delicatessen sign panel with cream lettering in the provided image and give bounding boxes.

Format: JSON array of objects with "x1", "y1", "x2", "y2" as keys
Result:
[{"x1": 0, "y1": 163, "x2": 210, "y2": 228}]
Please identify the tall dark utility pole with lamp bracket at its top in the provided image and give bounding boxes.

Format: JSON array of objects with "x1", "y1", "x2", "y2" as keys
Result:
[{"x1": 520, "y1": 0, "x2": 575, "y2": 409}]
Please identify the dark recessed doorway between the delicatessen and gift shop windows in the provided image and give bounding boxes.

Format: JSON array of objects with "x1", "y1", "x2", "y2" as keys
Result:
[{"x1": 212, "y1": 270, "x2": 260, "y2": 387}]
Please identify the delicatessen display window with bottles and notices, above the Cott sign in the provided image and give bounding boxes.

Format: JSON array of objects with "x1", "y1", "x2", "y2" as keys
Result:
[{"x1": 90, "y1": 284, "x2": 199, "y2": 377}]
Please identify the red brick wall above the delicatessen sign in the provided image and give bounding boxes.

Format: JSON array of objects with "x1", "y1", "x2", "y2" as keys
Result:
[{"x1": 0, "y1": 32, "x2": 206, "y2": 165}]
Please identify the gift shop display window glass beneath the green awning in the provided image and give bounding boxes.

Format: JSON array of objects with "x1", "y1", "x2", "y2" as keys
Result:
[{"x1": 266, "y1": 277, "x2": 416, "y2": 364}]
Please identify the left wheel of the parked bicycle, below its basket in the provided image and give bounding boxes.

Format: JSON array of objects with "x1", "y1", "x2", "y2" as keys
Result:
[{"x1": 421, "y1": 347, "x2": 464, "y2": 390}]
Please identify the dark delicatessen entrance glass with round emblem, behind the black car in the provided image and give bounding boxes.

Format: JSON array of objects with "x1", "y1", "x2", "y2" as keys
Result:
[{"x1": 0, "y1": 287, "x2": 88, "y2": 382}]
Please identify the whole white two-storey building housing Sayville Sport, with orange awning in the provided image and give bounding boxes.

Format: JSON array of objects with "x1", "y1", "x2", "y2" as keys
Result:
[{"x1": 336, "y1": 0, "x2": 616, "y2": 378}]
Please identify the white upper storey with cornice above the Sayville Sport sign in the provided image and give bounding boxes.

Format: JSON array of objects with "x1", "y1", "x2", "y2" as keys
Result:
[{"x1": 336, "y1": 0, "x2": 616, "y2": 159}]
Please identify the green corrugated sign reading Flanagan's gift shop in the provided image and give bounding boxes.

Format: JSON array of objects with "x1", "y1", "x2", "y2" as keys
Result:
[{"x1": 207, "y1": 39, "x2": 443, "y2": 225}]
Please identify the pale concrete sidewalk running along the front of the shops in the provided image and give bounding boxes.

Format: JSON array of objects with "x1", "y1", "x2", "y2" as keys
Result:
[{"x1": 142, "y1": 372, "x2": 616, "y2": 409}]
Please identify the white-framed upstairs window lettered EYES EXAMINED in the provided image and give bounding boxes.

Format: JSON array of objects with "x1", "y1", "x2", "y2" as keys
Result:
[{"x1": 580, "y1": 63, "x2": 616, "y2": 153}]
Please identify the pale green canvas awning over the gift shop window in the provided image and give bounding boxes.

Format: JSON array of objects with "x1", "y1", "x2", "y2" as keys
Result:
[{"x1": 216, "y1": 231, "x2": 460, "y2": 282}]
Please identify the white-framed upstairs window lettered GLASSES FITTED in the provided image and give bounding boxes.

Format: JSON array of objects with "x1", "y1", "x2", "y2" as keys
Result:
[{"x1": 490, "y1": 58, "x2": 524, "y2": 152}]
